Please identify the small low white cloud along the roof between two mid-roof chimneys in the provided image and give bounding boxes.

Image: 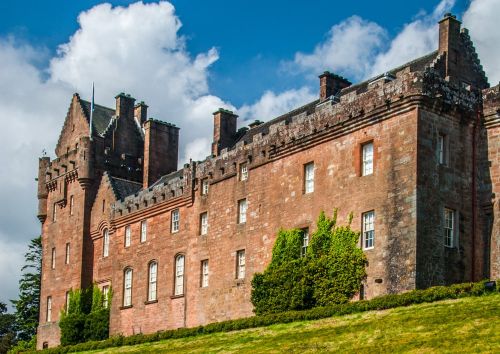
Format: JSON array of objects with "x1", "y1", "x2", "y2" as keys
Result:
[{"x1": 238, "y1": 87, "x2": 318, "y2": 121}]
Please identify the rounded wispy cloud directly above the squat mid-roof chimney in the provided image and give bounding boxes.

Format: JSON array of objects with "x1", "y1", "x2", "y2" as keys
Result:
[{"x1": 294, "y1": 16, "x2": 387, "y2": 77}]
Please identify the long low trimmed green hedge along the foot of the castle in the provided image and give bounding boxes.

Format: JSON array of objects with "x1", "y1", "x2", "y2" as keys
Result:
[{"x1": 37, "y1": 280, "x2": 500, "y2": 353}]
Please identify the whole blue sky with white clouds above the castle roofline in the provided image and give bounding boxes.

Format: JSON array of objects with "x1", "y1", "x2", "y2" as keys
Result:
[{"x1": 0, "y1": 0, "x2": 500, "y2": 308}]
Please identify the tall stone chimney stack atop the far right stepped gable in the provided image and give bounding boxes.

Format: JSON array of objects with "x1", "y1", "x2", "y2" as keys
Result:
[{"x1": 439, "y1": 13, "x2": 461, "y2": 77}]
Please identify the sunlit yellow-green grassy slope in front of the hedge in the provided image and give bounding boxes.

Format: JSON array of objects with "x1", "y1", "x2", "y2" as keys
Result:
[{"x1": 84, "y1": 294, "x2": 500, "y2": 353}]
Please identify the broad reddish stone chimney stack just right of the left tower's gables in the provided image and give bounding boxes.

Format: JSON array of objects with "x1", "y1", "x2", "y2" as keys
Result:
[{"x1": 142, "y1": 118, "x2": 179, "y2": 188}]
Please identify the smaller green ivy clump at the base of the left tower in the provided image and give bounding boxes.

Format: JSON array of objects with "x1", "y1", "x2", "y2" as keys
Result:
[{"x1": 59, "y1": 285, "x2": 112, "y2": 345}]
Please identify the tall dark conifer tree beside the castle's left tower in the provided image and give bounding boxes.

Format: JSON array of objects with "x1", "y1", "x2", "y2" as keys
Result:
[{"x1": 11, "y1": 237, "x2": 42, "y2": 341}]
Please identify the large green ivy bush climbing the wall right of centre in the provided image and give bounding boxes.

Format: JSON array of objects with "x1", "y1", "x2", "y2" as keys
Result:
[{"x1": 251, "y1": 210, "x2": 366, "y2": 315}]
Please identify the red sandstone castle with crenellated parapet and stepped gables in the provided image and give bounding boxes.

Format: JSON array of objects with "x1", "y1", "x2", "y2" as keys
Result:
[{"x1": 37, "y1": 14, "x2": 500, "y2": 348}]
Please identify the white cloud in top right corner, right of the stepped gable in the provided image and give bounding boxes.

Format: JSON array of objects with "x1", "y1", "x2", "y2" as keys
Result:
[{"x1": 463, "y1": 0, "x2": 500, "y2": 86}]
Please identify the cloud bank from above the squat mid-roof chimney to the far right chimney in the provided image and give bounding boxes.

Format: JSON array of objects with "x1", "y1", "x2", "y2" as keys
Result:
[{"x1": 285, "y1": 0, "x2": 455, "y2": 80}]
